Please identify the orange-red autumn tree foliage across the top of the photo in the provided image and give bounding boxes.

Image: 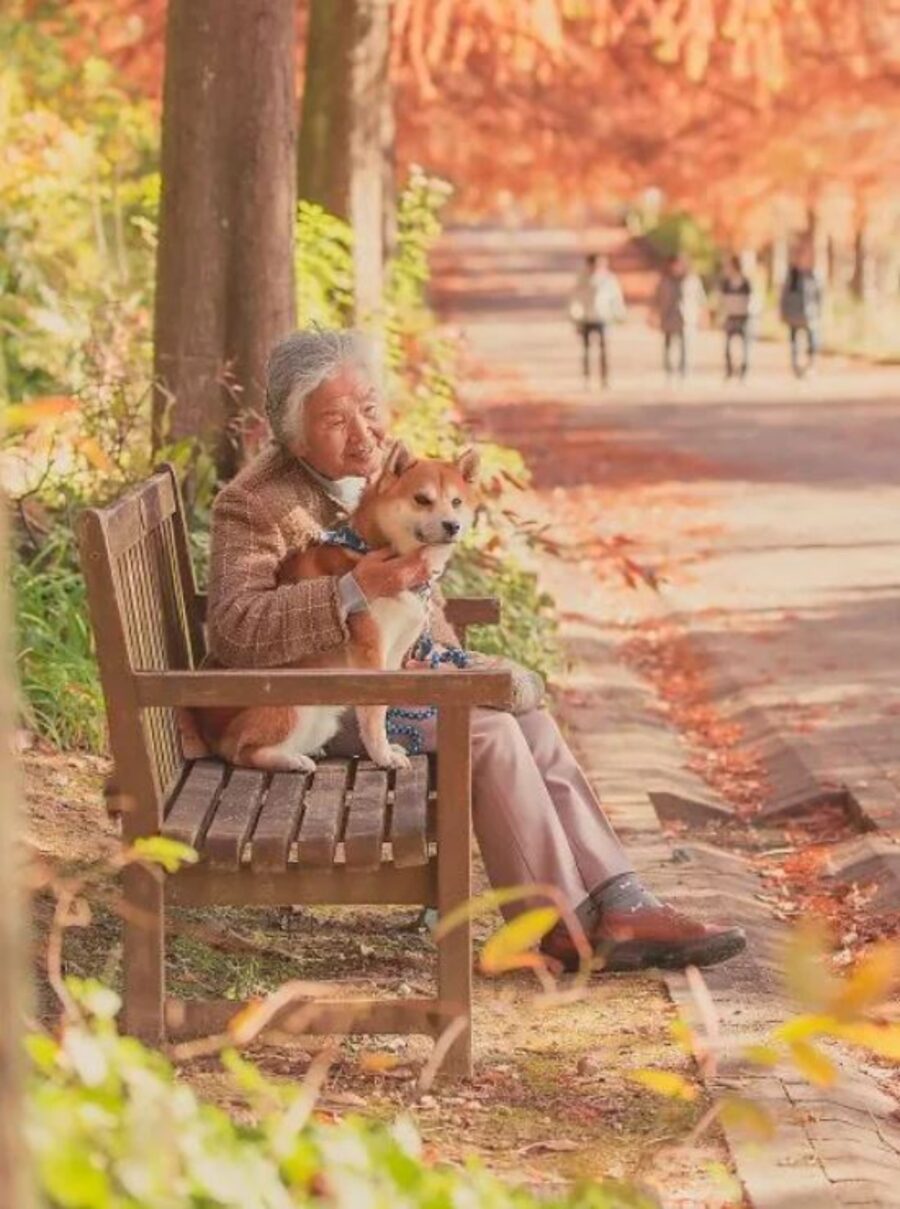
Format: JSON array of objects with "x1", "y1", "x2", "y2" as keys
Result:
[{"x1": 35, "y1": 0, "x2": 900, "y2": 243}]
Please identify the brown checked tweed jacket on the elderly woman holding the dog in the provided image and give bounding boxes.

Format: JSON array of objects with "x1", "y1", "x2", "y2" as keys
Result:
[{"x1": 207, "y1": 490, "x2": 350, "y2": 667}]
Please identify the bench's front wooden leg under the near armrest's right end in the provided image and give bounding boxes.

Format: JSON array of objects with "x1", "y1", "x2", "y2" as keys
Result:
[{"x1": 438, "y1": 706, "x2": 472, "y2": 1078}]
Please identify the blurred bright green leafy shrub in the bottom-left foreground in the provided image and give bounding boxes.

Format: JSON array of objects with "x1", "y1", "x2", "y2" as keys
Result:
[{"x1": 27, "y1": 980, "x2": 657, "y2": 1209}]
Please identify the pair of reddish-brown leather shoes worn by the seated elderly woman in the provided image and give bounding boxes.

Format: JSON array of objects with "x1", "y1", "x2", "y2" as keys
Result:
[{"x1": 541, "y1": 906, "x2": 746, "y2": 971}]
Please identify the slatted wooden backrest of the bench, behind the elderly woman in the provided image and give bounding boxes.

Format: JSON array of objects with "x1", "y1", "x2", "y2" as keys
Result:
[{"x1": 79, "y1": 465, "x2": 203, "y2": 825}]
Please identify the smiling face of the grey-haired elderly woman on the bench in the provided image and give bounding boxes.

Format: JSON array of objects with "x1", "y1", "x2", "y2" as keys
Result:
[{"x1": 292, "y1": 369, "x2": 385, "y2": 479}]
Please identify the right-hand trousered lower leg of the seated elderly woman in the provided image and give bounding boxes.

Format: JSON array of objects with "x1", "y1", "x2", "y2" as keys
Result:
[{"x1": 515, "y1": 710, "x2": 634, "y2": 890}]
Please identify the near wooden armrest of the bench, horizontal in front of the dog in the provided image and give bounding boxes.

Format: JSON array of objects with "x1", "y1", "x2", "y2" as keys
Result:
[{"x1": 132, "y1": 669, "x2": 513, "y2": 710}]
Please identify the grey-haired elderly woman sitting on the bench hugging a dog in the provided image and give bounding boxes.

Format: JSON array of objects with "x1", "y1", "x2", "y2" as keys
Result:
[{"x1": 208, "y1": 330, "x2": 745, "y2": 970}]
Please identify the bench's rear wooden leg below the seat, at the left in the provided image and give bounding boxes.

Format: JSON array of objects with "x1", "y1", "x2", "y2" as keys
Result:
[{"x1": 122, "y1": 864, "x2": 166, "y2": 1046}]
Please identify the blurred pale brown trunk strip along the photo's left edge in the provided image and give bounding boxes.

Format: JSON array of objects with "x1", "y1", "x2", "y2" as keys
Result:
[{"x1": 0, "y1": 496, "x2": 34, "y2": 1209}]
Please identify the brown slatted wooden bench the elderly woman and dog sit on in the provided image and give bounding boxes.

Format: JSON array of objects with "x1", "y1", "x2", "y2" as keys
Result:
[{"x1": 79, "y1": 467, "x2": 509, "y2": 1075}]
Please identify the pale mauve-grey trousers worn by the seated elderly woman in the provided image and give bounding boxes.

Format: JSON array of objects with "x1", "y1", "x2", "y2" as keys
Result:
[{"x1": 328, "y1": 710, "x2": 633, "y2": 918}]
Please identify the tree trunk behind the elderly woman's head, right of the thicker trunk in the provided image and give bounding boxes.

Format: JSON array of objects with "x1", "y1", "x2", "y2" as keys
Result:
[{"x1": 299, "y1": 0, "x2": 393, "y2": 326}]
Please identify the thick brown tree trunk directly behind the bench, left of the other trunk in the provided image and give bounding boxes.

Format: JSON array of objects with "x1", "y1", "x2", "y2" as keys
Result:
[{"x1": 154, "y1": 0, "x2": 295, "y2": 478}]
